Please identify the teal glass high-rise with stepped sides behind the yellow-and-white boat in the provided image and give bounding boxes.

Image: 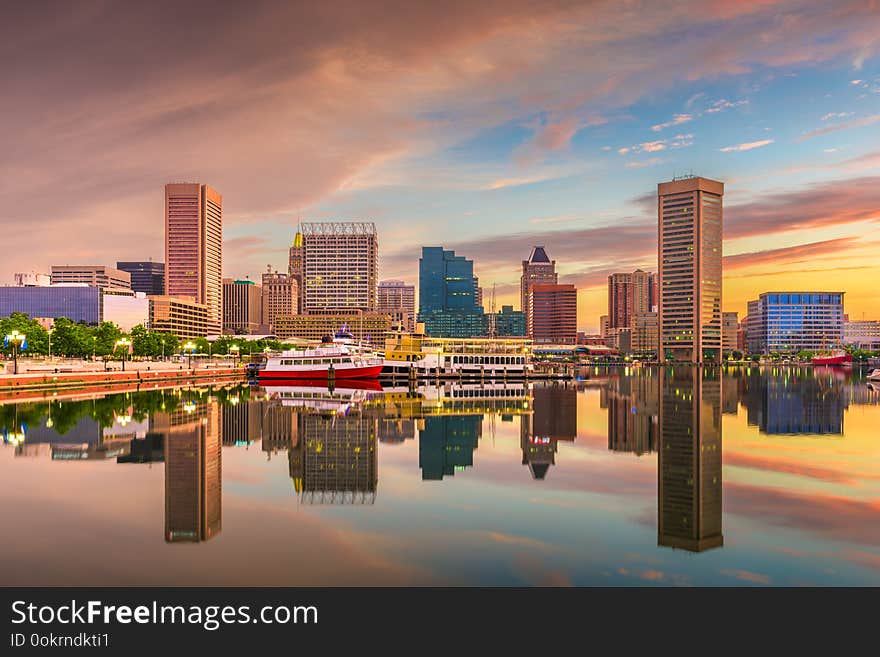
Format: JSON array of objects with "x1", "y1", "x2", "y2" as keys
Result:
[{"x1": 418, "y1": 246, "x2": 484, "y2": 338}]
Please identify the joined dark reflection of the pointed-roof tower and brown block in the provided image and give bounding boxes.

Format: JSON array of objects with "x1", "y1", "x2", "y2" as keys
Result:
[{"x1": 520, "y1": 384, "x2": 577, "y2": 479}]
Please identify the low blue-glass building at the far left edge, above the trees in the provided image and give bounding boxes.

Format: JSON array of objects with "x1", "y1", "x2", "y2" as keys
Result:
[{"x1": 0, "y1": 283, "x2": 104, "y2": 326}]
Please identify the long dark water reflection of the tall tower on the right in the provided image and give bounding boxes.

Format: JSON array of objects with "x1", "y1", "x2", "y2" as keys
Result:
[{"x1": 657, "y1": 366, "x2": 724, "y2": 552}]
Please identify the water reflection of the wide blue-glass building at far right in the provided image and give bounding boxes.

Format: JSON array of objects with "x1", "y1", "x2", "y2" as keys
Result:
[{"x1": 743, "y1": 367, "x2": 848, "y2": 435}]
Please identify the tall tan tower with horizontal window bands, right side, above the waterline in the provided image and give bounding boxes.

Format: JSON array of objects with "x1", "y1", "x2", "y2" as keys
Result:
[{"x1": 657, "y1": 176, "x2": 724, "y2": 363}]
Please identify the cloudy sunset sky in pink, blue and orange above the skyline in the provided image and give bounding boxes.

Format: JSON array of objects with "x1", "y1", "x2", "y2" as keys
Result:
[{"x1": 0, "y1": 0, "x2": 880, "y2": 331}]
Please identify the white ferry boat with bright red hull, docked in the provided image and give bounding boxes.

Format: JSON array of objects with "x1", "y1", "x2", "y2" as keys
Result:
[{"x1": 260, "y1": 336, "x2": 384, "y2": 382}]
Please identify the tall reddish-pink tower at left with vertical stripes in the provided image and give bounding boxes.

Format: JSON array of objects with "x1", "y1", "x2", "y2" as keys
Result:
[{"x1": 165, "y1": 183, "x2": 223, "y2": 335}]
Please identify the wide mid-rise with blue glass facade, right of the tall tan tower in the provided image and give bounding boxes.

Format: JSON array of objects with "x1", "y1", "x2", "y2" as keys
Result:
[{"x1": 748, "y1": 292, "x2": 844, "y2": 354}]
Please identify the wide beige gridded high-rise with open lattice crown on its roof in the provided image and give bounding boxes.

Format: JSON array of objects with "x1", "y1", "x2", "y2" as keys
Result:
[{"x1": 300, "y1": 221, "x2": 379, "y2": 313}]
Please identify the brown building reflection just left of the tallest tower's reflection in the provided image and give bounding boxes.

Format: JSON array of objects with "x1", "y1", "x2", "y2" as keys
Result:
[{"x1": 600, "y1": 368, "x2": 659, "y2": 456}]
